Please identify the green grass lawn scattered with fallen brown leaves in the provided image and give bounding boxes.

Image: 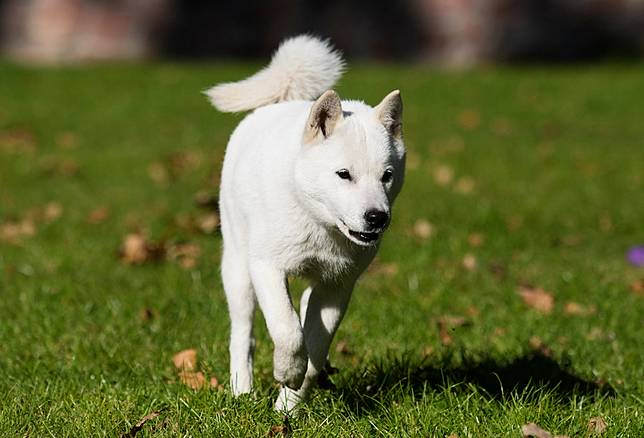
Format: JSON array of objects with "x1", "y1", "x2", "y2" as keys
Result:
[{"x1": 0, "y1": 63, "x2": 644, "y2": 437}]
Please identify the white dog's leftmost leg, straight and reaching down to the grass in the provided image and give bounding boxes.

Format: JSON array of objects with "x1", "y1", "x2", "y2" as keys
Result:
[{"x1": 221, "y1": 244, "x2": 255, "y2": 396}]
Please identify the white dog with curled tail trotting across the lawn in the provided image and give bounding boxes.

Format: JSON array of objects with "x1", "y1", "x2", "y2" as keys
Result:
[{"x1": 206, "y1": 36, "x2": 405, "y2": 412}]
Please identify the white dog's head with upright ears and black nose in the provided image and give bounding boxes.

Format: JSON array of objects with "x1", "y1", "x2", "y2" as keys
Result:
[{"x1": 295, "y1": 90, "x2": 405, "y2": 246}]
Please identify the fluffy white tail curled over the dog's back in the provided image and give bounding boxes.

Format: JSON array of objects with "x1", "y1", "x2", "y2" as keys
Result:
[{"x1": 205, "y1": 35, "x2": 344, "y2": 113}]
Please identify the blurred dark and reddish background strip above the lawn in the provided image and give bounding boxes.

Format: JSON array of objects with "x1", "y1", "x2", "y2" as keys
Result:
[{"x1": 0, "y1": 0, "x2": 644, "y2": 66}]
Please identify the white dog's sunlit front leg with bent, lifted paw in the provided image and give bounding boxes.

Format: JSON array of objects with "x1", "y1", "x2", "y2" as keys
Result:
[{"x1": 250, "y1": 260, "x2": 307, "y2": 389}]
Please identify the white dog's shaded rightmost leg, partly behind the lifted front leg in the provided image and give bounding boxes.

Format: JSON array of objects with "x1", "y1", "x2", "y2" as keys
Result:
[{"x1": 275, "y1": 282, "x2": 354, "y2": 412}]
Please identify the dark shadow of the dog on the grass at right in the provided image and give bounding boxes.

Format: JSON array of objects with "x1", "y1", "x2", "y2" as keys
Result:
[{"x1": 330, "y1": 351, "x2": 615, "y2": 413}]
